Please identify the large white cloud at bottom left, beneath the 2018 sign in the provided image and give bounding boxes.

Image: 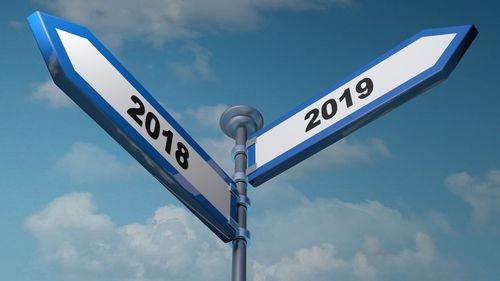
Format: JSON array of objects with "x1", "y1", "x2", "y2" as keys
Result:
[{"x1": 26, "y1": 193, "x2": 230, "y2": 281}]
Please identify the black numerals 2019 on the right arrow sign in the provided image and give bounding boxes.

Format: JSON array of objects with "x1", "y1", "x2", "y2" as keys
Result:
[{"x1": 304, "y1": 77, "x2": 373, "y2": 132}]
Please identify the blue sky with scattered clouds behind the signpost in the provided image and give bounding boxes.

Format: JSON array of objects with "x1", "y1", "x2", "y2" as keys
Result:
[{"x1": 0, "y1": 0, "x2": 500, "y2": 281}]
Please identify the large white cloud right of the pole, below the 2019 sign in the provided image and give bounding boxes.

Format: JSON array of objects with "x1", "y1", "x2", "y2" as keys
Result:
[{"x1": 250, "y1": 182, "x2": 461, "y2": 281}]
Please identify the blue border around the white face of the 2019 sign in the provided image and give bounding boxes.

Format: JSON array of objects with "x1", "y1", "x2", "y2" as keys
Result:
[{"x1": 248, "y1": 25, "x2": 478, "y2": 187}]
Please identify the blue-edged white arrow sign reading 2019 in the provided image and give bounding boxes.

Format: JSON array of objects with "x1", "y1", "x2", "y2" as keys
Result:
[{"x1": 248, "y1": 25, "x2": 477, "y2": 186}]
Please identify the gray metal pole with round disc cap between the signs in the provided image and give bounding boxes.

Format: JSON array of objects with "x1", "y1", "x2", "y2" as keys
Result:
[{"x1": 220, "y1": 105, "x2": 264, "y2": 281}]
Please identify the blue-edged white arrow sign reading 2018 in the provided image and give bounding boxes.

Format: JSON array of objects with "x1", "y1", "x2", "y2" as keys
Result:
[{"x1": 28, "y1": 12, "x2": 238, "y2": 242}]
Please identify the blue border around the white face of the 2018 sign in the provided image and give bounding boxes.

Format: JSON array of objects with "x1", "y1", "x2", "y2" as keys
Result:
[{"x1": 28, "y1": 11, "x2": 238, "y2": 242}]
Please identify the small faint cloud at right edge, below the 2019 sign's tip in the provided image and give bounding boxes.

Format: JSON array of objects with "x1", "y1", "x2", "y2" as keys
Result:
[{"x1": 445, "y1": 170, "x2": 500, "y2": 228}]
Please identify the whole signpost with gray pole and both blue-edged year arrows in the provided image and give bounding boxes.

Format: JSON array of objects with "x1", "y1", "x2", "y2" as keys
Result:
[{"x1": 28, "y1": 9, "x2": 477, "y2": 281}]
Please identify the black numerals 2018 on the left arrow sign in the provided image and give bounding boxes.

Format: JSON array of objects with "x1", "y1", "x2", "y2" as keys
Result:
[{"x1": 127, "y1": 96, "x2": 189, "y2": 170}]
